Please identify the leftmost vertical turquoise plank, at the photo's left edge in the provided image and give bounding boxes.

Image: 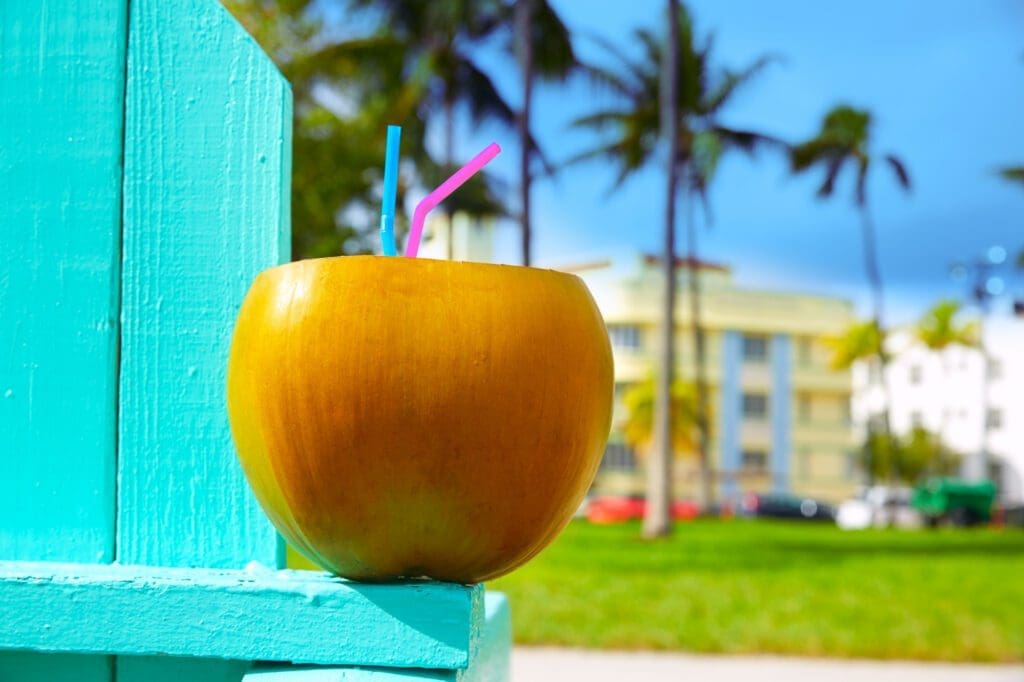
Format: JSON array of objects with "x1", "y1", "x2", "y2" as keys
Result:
[{"x1": 0, "y1": 0, "x2": 127, "y2": 561}]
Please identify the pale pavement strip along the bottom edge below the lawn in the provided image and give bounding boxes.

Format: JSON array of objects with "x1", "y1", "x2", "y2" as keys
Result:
[{"x1": 512, "y1": 647, "x2": 1024, "y2": 682}]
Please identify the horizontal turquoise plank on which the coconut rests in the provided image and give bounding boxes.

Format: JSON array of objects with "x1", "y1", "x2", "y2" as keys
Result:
[{"x1": 0, "y1": 561, "x2": 484, "y2": 667}]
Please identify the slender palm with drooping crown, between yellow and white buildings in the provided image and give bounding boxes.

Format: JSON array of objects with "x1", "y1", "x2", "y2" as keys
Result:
[{"x1": 791, "y1": 104, "x2": 910, "y2": 450}]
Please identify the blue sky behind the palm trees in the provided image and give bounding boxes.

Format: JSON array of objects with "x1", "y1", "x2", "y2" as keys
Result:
[{"x1": 448, "y1": 0, "x2": 1024, "y2": 322}]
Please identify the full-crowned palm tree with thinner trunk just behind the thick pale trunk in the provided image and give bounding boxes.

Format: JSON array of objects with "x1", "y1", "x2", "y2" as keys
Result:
[{"x1": 570, "y1": 2, "x2": 778, "y2": 528}]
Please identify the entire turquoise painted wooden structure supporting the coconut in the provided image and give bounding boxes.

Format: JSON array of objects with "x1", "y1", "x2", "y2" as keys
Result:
[{"x1": 0, "y1": 0, "x2": 509, "y2": 682}]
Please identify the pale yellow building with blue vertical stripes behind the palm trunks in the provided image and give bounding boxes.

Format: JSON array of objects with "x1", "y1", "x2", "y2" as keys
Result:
[{"x1": 558, "y1": 255, "x2": 859, "y2": 501}]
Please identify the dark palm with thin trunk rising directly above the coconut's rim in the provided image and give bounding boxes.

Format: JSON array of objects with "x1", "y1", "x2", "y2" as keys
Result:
[{"x1": 514, "y1": 0, "x2": 578, "y2": 265}]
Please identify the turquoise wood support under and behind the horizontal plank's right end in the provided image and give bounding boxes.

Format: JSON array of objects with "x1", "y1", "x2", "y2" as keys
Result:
[{"x1": 244, "y1": 592, "x2": 512, "y2": 682}]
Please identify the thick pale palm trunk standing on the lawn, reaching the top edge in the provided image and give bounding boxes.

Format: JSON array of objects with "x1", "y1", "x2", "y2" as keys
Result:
[{"x1": 643, "y1": 0, "x2": 679, "y2": 538}]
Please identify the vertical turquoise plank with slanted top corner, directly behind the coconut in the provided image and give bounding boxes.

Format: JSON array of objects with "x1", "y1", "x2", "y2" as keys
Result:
[{"x1": 118, "y1": 0, "x2": 291, "y2": 567}]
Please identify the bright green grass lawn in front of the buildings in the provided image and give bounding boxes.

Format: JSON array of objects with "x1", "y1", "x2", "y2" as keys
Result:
[{"x1": 489, "y1": 520, "x2": 1024, "y2": 662}]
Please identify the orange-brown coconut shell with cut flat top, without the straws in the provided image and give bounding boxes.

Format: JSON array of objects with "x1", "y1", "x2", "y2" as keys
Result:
[{"x1": 227, "y1": 251, "x2": 613, "y2": 584}]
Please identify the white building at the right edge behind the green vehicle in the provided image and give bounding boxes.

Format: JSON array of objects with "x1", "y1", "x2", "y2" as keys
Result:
[{"x1": 853, "y1": 318, "x2": 1024, "y2": 504}]
